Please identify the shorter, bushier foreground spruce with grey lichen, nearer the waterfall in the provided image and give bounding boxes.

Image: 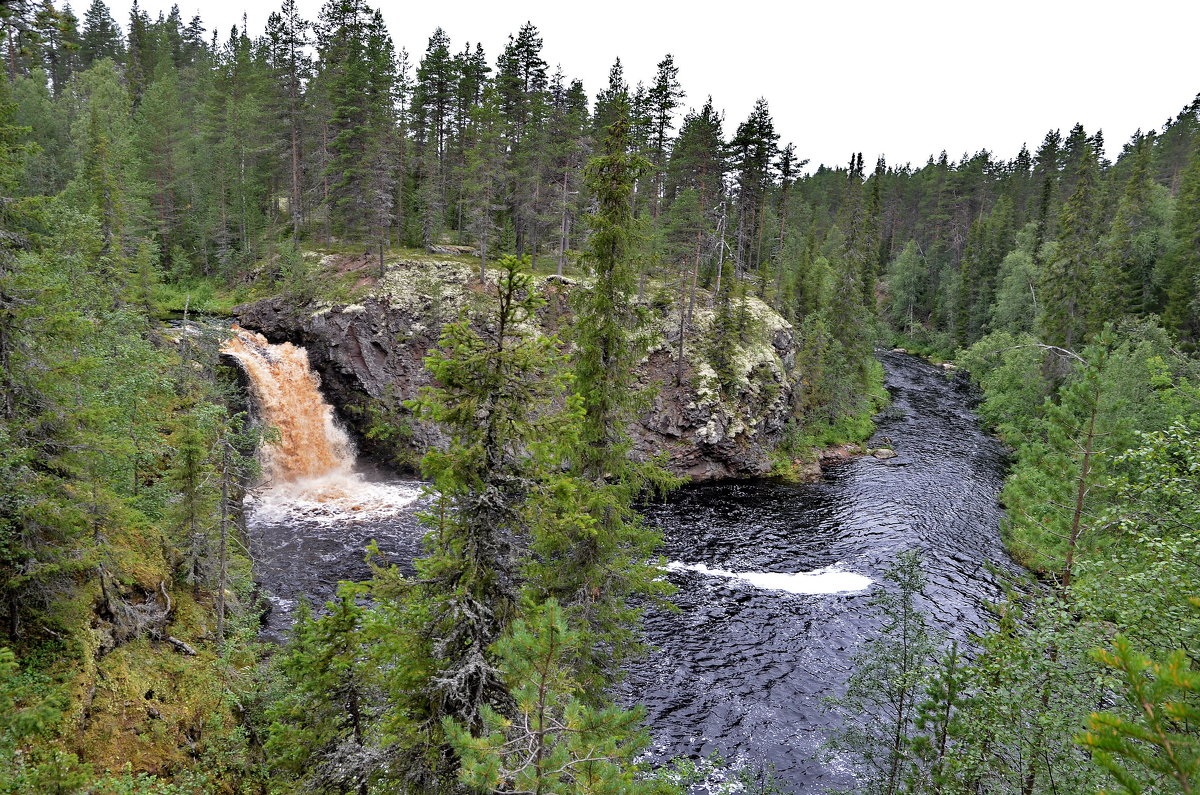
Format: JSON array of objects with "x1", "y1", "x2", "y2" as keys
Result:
[{"x1": 413, "y1": 256, "x2": 562, "y2": 733}]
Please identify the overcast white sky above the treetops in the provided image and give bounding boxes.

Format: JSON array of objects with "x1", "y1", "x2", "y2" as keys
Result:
[{"x1": 108, "y1": 0, "x2": 1200, "y2": 174}]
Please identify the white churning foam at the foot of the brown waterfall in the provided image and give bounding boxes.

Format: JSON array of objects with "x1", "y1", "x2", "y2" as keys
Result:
[{"x1": 246, "y1": 472, "x2": 425, "y2": 525}]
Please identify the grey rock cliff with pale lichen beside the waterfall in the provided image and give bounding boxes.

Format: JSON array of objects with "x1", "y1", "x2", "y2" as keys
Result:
[{"x1": 238, "y1": 261, "x2": 797, "y2": 480}]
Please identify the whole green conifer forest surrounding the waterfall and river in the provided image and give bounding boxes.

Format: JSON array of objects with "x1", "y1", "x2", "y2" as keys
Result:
[{"x1": 0, "y1": 0, "x2": 1200, "y2": 795}]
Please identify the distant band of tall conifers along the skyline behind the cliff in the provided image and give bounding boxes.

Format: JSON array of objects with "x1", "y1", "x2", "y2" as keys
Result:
[{"x1": 5, "y1": 0, "x2": 1200, "y2": 349}]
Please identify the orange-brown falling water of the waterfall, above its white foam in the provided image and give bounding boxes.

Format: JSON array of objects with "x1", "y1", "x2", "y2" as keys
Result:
[{"x1": 223, "y1": 325, "x2": 354, "y2": 486}]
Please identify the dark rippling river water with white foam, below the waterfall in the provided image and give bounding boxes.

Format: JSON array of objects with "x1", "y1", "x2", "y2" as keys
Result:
[{"x1": 251, "y1": 353, "x2": 1013, "y2": 793}]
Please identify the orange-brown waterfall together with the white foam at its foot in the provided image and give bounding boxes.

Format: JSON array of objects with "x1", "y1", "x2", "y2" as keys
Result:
[{"x1": 222, "y1": 325, "x2": 416, "y2": 522}]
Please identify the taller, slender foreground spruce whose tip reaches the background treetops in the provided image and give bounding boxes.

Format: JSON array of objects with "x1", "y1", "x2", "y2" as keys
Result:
[{"x1": 535, "y1": 109, "x2": 671, "y2": 693}]
